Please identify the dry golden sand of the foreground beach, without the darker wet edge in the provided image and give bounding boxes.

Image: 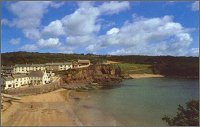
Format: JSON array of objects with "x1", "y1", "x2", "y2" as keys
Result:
[{"x1": 1, "y1": 89, "x2": 82, "y2": 126}]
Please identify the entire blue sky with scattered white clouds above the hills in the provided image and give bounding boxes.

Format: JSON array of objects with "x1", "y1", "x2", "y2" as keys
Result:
[{"x1": 1, "y1": 1, "x2": 199, "y2": 56}]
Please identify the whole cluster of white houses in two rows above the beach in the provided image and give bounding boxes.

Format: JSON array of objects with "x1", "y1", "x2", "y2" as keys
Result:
[{"x1": 1, "y1": 60, "x2": 90, "y2": 89}]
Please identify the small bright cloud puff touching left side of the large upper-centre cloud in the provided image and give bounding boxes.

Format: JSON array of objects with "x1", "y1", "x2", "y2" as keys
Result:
[{"x1": 43, "y1": 20, "x2": 65, "y2": 36}]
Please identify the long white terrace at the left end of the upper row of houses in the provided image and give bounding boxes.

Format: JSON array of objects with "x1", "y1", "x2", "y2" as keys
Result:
[{"x1": 13, "y1": 64, "x2": 46, "y2": 73}]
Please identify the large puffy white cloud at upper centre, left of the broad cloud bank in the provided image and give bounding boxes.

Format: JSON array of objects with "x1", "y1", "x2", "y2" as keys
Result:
[{"x1": 61, "y1": 5, "x2": 100, "y2": 36}]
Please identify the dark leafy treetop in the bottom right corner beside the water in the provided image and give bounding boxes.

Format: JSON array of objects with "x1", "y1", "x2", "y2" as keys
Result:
[{"x1": 162, "y1": 100, "x2": 199, "y2": 126}]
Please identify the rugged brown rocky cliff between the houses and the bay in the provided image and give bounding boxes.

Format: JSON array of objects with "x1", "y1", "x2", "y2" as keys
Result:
[{"x1": 62, "y1": 64, "x2": 122, "y2": 85}]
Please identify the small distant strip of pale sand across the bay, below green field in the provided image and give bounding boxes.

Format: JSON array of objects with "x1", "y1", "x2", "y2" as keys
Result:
[{"x1": 129, "y1": 74, "x2": 164, "y2": 79}]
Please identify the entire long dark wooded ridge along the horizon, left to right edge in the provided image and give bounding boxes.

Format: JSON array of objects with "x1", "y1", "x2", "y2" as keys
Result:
[{"x1": 1, "y1": 52, "x2": 199, "y2": 78}]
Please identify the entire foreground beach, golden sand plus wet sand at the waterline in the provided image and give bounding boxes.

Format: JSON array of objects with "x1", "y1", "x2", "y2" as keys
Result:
[{"x1": 1, "y1": 89, "x2": 119, "y2": 126}]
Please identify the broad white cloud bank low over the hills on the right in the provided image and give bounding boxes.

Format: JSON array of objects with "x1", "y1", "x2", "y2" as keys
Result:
[{"x1": 102, "y1": 16, "x2": 193, "y2": 55}]
